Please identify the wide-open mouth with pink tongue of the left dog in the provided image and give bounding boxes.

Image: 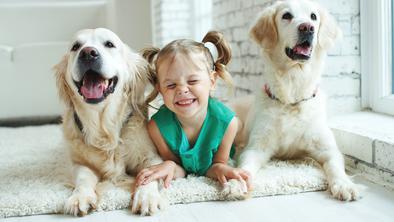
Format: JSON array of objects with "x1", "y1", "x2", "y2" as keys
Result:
[{"x1": 74, "y1": 70, "x2": 118, "y2": 104}]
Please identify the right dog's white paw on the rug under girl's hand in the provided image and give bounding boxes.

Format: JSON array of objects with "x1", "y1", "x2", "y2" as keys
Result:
[{"x1": 222, "y1": 179, "x2": 250, "y2": 200}]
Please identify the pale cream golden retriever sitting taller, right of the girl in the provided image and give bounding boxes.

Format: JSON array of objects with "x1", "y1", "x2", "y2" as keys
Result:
[{"x1": 225, "y1": 0, "x2": 361, "y2": 201}]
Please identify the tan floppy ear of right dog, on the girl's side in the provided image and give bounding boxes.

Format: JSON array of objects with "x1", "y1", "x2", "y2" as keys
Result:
[{"x1": 249, "y1": 5, "x2": 278, "y2": 48}]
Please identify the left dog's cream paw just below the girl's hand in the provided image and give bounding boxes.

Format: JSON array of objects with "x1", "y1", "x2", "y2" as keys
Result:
[{"x1": 131, "y1": 182, "x2": 168, "y2": 216}]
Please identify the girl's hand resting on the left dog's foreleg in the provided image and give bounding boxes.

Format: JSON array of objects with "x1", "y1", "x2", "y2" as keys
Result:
[{"x1": 136, "y1": 160, "x2": 185, "y2": 188}]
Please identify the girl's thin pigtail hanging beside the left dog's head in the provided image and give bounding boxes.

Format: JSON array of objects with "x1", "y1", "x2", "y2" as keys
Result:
[{"x1": 142, "y1": 47, "x2": 160, "y2": 104}]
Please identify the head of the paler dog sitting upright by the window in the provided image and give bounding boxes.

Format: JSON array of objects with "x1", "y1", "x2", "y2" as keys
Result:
[{"x1": 250, "y1": 0, "x2": 340, "y2": 64}]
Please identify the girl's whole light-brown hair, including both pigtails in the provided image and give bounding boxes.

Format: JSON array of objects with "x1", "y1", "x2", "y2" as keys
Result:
[{"x1": 142, "y1": 31, "x2": 233, "y2": 102}]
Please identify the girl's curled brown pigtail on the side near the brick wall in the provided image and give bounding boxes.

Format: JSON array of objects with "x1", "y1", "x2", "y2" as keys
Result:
[{"x1": 202, "y1": 31, "x2": 234, "y2": 87}]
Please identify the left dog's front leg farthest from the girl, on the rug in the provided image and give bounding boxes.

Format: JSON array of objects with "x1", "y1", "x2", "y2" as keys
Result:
[{"x1": 64, "y1": 165, "x2": 98, "y2": 216}]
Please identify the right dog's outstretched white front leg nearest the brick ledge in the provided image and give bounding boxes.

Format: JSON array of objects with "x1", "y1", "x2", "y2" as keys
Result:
[{"x1": 311, "y1": 129, "x2": 363, "y2": 201}]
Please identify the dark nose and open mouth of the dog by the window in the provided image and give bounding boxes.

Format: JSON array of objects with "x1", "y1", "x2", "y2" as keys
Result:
[{"x1": 285, "y1": 23, "x2": 315, "y2": 61}]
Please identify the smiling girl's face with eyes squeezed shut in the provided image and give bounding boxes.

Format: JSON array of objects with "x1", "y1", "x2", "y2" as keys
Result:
[{"x1": 157, "y1": 53, "x2": 216, "y2": 118}]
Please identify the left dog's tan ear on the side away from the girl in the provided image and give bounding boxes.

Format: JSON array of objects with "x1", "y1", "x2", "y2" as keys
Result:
[{"x1": 53, "y1": 54, "x2": 72, "y2": 107}]
